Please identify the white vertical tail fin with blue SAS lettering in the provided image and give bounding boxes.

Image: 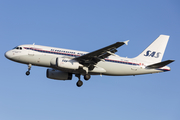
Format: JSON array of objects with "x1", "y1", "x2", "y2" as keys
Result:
[{"x1": 135, "y1": 35, "x2": 170, "y2": 63}]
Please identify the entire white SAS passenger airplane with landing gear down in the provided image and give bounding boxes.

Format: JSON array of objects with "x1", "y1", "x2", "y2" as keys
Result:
[{"x1": 5, "y1": 35, "x2": 174, "y2": 87}]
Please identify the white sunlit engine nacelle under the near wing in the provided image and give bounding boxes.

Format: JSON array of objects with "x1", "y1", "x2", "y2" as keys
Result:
[{"x1": 56, "y1": 58, "x2": 82, "y2": 70}]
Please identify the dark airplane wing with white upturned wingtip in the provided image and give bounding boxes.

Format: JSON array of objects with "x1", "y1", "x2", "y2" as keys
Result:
[{"x1": 74, "y1": 40, "x2": 129, "y2": 67}]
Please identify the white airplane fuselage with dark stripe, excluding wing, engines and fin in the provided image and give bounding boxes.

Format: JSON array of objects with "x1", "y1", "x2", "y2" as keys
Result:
[{"x1": 5, "y1": 45, "x2": 170, "y2": 76}]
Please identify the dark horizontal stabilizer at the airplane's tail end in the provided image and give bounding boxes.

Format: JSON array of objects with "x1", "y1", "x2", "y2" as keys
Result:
[{"x1": 146, "y1": 60, "x2": 174, "y2": 69}]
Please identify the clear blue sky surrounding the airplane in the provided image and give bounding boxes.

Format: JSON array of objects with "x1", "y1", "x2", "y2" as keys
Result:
[{"x1": 0, "y1": 0, "x2": 180, "y2": 120}]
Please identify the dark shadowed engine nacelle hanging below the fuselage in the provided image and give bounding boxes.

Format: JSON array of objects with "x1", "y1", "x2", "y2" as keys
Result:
[{"x1": 46, "y1": 69, "x2": 72, "y2": 80}]
